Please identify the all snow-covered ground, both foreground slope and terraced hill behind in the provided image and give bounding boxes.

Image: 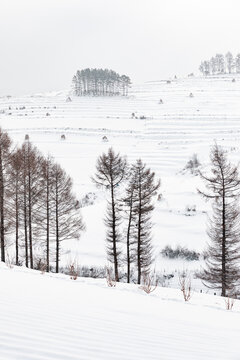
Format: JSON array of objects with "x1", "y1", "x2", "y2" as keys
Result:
[{"x1": 0, "y1": 76, "x2": 240, "y2": 360}]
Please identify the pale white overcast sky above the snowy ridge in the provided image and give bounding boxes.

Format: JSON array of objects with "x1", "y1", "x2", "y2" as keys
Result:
[{"x1": 0, "y1": 0, "x2": 240, "y2": 95}]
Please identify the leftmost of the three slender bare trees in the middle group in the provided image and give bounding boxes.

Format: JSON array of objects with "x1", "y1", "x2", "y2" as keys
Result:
[{"x1": 92, "y1": 148, "x2": 127, "y2": 281}]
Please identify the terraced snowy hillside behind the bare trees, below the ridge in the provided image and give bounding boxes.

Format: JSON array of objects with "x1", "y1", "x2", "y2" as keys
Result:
[{"x1": 0, "y1": 75, "x2": 240, "y2": 287}]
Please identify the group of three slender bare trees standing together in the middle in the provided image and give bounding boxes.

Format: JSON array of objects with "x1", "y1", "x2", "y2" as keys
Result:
[{"x1": 92, "y1": 148, "x2": 160, "y2": 284}]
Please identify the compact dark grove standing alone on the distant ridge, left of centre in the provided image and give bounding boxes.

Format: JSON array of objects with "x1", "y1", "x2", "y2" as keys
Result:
[{"x1": 73, "y1": 69, "x2": 131, "y2": 96}]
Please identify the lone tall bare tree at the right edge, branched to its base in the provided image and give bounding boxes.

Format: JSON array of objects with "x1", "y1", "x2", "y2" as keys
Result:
[{"x1": 198, "y1": 145, "x2": 240, "y2": 296}]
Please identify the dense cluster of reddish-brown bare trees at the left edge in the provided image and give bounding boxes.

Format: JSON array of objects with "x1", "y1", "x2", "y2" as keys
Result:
[{"x1": 0, "y1": 129, "x2": 84, "y2": 272}]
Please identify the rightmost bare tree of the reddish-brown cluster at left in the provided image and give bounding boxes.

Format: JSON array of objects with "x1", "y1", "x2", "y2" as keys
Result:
[{"x1": 51, "y1": 164, "x2": 85, "y2": 273}]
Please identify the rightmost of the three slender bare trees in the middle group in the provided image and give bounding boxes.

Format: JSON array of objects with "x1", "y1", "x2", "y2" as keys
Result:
[{"x1": 133, "y1": 159, "x2": 160, "y2": 284}]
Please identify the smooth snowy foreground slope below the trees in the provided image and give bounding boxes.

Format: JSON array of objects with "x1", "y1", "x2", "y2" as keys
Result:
[{"x1": 0, "y1": 264, "x2": 240, "y2": 360}]
